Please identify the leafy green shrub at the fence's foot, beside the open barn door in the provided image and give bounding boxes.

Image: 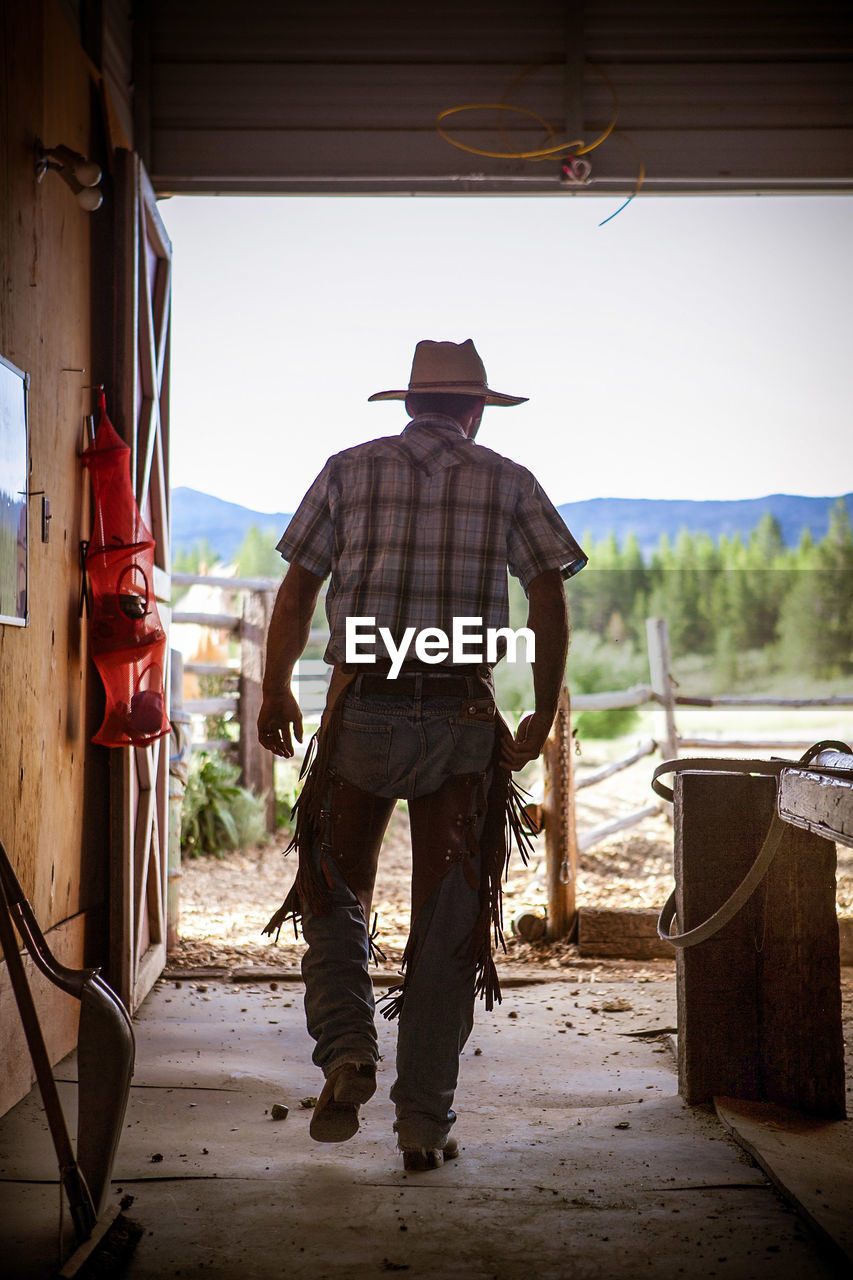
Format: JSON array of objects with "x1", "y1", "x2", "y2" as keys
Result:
[{"x1": 181, "y1": 751, "x2": 266, "y2": 858}]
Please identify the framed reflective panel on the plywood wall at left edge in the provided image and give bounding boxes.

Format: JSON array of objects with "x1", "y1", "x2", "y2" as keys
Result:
[{"x1": 0, "y1": 356, "x2": 29, "y2": 627}]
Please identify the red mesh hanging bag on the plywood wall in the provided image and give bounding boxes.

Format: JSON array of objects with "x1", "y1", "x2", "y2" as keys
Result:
[{"x1": 83, "y1": 392, "x2": 170, "y2": 746}]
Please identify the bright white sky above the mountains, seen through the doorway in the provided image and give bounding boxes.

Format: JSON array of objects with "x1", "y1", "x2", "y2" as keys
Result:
[{"x1": 159, "y1": 196, "x2": 853, "y2": 511}]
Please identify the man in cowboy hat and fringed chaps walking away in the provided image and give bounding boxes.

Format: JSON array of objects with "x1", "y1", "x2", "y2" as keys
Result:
[{"x1": 257, "y1": 339, "x2": 587, "y2": 1171}]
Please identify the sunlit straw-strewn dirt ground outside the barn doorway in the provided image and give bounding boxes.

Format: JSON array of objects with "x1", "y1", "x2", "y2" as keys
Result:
[{"x1": 169, "y1": 756, "x2": 853, "y2": 972}]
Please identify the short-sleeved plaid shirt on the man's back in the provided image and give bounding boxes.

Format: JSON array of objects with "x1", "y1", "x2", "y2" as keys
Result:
[{"x1": 278, "y1": 413, "x2": 587, "y2": 663}]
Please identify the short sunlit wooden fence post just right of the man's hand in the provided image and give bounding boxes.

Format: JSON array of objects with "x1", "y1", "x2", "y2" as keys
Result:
[{"x1": 542, "y1": 685, "x2": 578, "y2": 940}]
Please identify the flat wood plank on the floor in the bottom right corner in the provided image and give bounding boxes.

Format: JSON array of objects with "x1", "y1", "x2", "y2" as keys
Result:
[{"x1": 713, "y1": 1098, "x2": 853, "y2": 1263}]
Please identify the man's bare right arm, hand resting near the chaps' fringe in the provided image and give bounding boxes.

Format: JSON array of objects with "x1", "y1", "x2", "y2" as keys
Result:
[{"x1": 501, "y1": 568, "x2": 569, "y2": 769}]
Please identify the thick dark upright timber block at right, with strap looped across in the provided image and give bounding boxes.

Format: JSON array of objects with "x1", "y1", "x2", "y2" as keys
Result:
[{"x1": 675, "y1": 772, "x2": 844, "y2": 1117}]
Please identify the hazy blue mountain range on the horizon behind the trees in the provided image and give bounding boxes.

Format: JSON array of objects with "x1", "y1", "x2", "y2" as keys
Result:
[{"x1": 172, "y1": 488, "x2": 853, "y2": 561}]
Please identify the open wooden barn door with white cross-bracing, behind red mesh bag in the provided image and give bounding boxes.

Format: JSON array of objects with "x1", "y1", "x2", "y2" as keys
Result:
[{"x1": 110, "y1": 151, "x2": 172, "y2": 1010}]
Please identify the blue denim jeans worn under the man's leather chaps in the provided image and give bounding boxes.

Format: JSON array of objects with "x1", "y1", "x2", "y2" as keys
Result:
[{"x1": 302, "y1": 678, "x2": 494, "y2": 1147}]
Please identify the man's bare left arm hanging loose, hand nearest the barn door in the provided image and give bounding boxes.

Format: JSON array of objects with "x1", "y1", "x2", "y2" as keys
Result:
[{"x1": 257, "y1": 564, "x2": 323, "y2": 758}]
